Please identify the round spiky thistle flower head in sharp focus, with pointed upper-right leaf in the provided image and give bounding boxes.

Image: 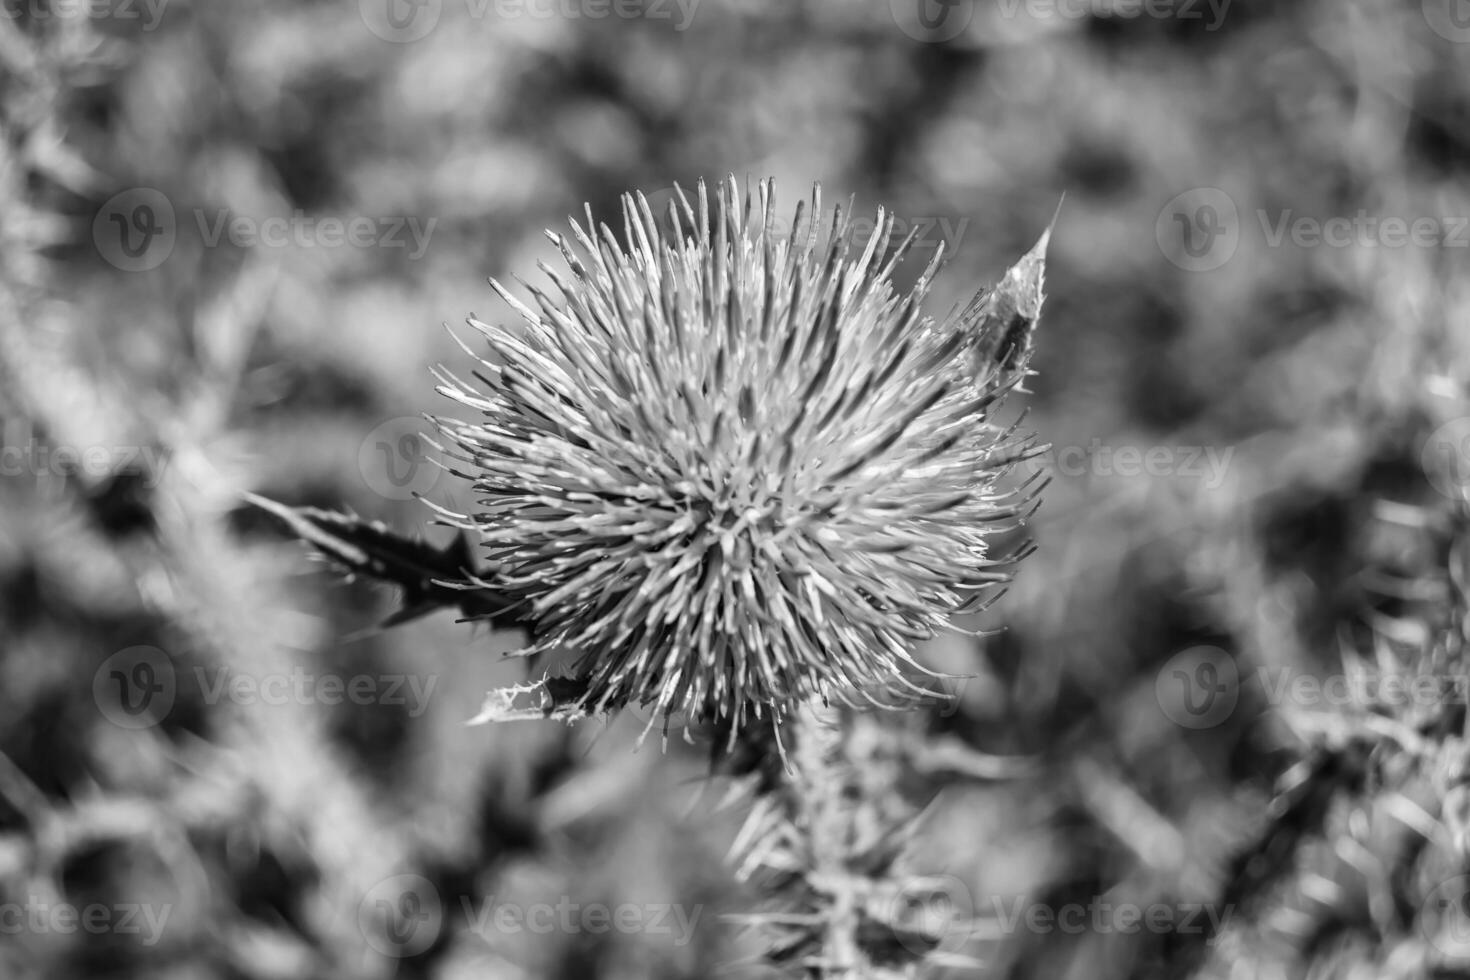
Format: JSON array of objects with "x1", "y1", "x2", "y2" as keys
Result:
[{"x1": 435, "y1": 178, "x2": 1045, "y2": 730}]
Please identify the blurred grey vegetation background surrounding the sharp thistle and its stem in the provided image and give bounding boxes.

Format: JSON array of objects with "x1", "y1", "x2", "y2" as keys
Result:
[{"x1": 0, "y1": 0, "x2": 1470, "y2": 980}]
